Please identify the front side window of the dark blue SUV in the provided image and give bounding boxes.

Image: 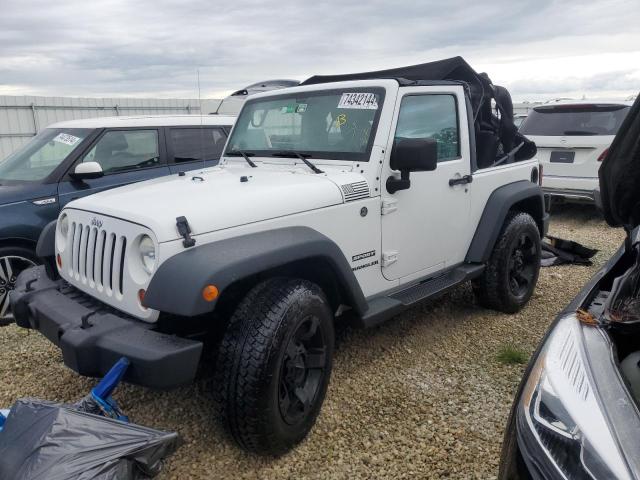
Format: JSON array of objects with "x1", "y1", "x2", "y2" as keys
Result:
[{"x1": 82, "y1": 130, "x2": 160, "y2": 174}]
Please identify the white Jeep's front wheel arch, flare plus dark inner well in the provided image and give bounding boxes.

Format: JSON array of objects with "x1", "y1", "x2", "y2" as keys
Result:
[{"x1": 144, "y1": 227, "x2": 367, "y2": 317}]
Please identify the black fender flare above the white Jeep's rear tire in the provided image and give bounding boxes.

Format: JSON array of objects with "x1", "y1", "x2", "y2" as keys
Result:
[{"x1": 465, "y1": 180, "x2": 549, "y2": 263}]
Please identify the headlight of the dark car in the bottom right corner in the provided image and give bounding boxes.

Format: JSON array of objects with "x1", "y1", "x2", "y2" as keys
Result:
[{"x1": 517, "y1": 315, "x2": 631, "y2": 479}]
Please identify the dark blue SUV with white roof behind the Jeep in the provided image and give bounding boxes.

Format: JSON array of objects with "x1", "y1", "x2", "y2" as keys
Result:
[{"x1": 0, "y1": 115, "x2": 235, "y2": 324}]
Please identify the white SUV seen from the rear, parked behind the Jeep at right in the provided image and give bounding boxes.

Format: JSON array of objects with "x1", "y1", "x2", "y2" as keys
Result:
[{"x1": 520, "y1": 100, "x2": 632, "y2": 201}]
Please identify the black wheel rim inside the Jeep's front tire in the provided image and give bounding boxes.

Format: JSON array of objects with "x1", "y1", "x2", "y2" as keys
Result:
[{"x1": 278, "y1": 316, "x2": 327, "y2": 425}]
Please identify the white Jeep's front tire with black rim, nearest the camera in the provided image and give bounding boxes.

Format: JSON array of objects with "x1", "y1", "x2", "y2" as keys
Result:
[{"x1": 216, "y1": 278, "x2": 334, "y2": 455}]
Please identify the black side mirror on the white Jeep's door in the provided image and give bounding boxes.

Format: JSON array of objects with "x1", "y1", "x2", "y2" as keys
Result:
[{"x1": 387, "y1": 138, "x2": 438, "y2": 193}]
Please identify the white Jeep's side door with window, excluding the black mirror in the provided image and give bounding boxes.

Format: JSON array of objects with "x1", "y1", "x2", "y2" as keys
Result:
[{"x1": 381, "y1": 86, "x2": 473, "y2": 283}]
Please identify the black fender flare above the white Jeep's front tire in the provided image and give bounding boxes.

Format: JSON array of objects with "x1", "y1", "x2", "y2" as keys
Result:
[{"x1": 144, "y1": 227, "x2": 367, "y2": 317}]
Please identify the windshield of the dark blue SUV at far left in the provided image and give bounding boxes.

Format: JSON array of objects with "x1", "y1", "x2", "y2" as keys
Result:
[{"x1": 0, "y1": 128, "x2": 92, "y2": 184}]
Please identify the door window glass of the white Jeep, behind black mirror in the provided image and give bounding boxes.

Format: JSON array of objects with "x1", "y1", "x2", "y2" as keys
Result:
[{"x1": 396, "y1": 95, "x2": 460, "y2": 162}]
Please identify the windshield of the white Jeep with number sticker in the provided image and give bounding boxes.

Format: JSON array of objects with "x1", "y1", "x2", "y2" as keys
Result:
[{"x1": 225, "y1": 88, "x2": 384, "y2": 162}]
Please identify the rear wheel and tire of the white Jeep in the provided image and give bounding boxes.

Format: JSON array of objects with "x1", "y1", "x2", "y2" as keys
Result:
[{"x1": 472, "y1": 212, "x2": 541, "y2": 313}]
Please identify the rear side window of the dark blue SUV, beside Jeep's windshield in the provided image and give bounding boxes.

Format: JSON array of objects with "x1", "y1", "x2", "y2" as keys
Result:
[{"x1": 169, "y1": 128, "x2": 227, "y2": 163}]
